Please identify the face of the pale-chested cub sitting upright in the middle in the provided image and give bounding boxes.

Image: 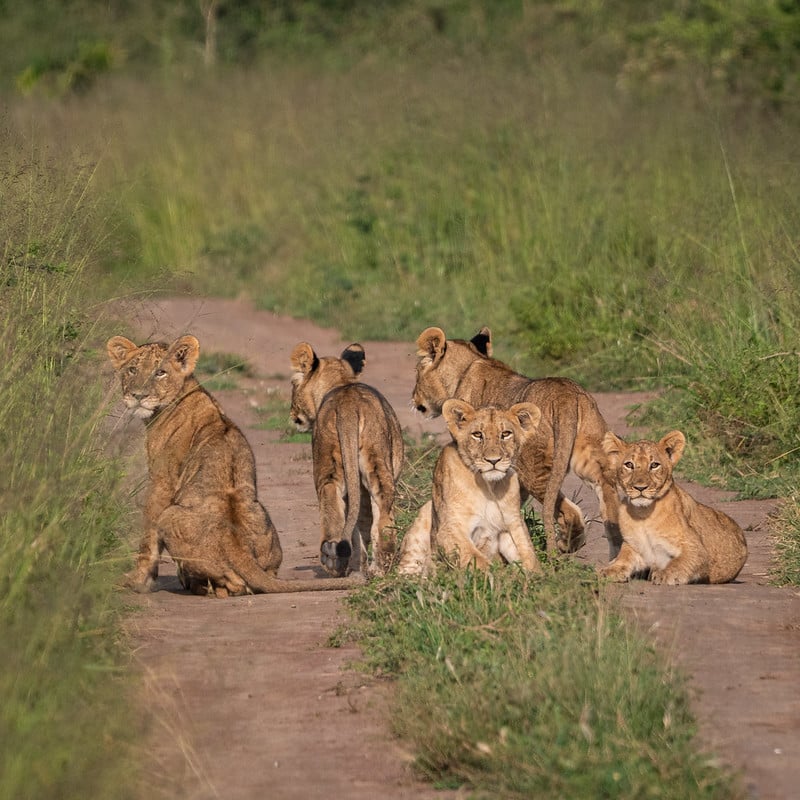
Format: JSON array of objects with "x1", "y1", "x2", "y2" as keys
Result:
[{"x1": 442, "y1": 398, "x2": 541, "y2": 483}]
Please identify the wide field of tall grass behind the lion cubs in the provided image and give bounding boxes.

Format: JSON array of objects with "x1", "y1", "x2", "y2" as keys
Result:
[{"x1": 10, "y1": 47, "x2": 800, "y2": 536}]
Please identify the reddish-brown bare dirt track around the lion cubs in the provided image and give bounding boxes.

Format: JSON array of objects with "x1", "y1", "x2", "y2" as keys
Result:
[{"x1": 117, "y1": 298, "x2": 800, "y2": 800}]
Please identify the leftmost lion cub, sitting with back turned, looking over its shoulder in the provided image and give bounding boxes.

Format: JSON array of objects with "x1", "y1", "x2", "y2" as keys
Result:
[{"x1": 107, "y1": 336, "x2": 355, "y2": 597}]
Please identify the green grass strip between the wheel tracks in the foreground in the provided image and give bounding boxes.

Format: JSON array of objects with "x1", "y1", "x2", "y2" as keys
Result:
[{"x1": 348, "y1": 565, "x2": 744, "y2": 800}]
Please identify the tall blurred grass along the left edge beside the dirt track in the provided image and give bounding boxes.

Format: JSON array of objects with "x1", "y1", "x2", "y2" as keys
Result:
[{"x1": 0, "y1": 125, "x2": 137, "y2": 800}]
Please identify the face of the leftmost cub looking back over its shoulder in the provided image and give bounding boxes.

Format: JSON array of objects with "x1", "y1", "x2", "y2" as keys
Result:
[{"x1": 106, "y1": 336, "x2": 200, "y2": 420}]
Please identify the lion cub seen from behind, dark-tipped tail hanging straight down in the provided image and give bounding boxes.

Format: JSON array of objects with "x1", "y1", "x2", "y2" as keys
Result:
[{"x1": 291, "y1": 342, "x2": 404, "y2": 575}]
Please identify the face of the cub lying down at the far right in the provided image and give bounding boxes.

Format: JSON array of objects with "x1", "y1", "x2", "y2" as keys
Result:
[{"x1": 603, "y1": 431, "x2": 686, "y2": 508}]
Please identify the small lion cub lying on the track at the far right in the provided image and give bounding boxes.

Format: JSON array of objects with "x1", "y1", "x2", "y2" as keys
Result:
[{"x1": 600, "y1": 431, "x2": 747, "y2": 585}]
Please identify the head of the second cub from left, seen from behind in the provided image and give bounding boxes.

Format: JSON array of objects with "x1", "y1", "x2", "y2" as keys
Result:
[{"x1": 290, "y1": 342, "x2": 366, "y2": 431}]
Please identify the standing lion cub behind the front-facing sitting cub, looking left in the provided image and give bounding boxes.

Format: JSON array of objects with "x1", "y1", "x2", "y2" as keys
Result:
[{"x1": 413, "y1": 327, "x2": 622, "y2": 558}]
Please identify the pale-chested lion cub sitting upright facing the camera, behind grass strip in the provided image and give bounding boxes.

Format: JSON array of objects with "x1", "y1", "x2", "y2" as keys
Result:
[{"x1": 398, "y1": 399, "x2": 541, "y2": 575}]
